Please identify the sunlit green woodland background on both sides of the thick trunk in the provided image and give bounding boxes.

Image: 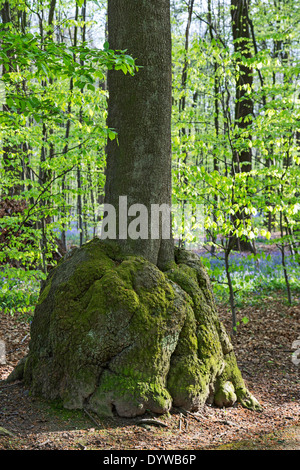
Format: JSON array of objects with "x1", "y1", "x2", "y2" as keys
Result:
[{"x1": 0, "y1": 0, "x2": 300, "y2": 327}]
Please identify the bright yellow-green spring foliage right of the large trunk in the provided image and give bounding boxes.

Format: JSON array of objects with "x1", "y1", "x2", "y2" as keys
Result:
[{"x1": 173, "y1": 0, "x2": 300, "y2": 324}]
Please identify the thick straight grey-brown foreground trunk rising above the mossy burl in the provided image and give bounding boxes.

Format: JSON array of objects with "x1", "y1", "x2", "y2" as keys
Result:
[{"x1": 105, "y1": 0, "x2": 174, "y2": 268}]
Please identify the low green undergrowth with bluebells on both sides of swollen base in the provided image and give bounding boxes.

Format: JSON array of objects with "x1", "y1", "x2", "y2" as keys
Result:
[{"x1": 0, "y1": 244, "x2": 300, "y2": 321}]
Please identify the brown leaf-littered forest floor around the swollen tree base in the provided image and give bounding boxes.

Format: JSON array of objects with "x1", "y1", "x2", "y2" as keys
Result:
[{"x1": 0, "y1": 284, "x2": 300, "y2": 451}]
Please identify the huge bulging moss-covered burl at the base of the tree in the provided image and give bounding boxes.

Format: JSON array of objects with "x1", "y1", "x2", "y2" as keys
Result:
[{"x1": 8, "y1": 239, "x2": 260, "y2": 417}]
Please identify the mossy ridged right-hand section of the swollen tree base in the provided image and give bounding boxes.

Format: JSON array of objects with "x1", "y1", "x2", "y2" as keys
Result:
[{"x1": 167, "y1": 250, "x2": 256, "y2": 408}]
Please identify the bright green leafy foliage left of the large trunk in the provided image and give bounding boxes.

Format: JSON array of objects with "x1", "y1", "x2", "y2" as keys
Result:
[{"x1": 0, "y1": 11, "x2": 136, "y2": 280}]
